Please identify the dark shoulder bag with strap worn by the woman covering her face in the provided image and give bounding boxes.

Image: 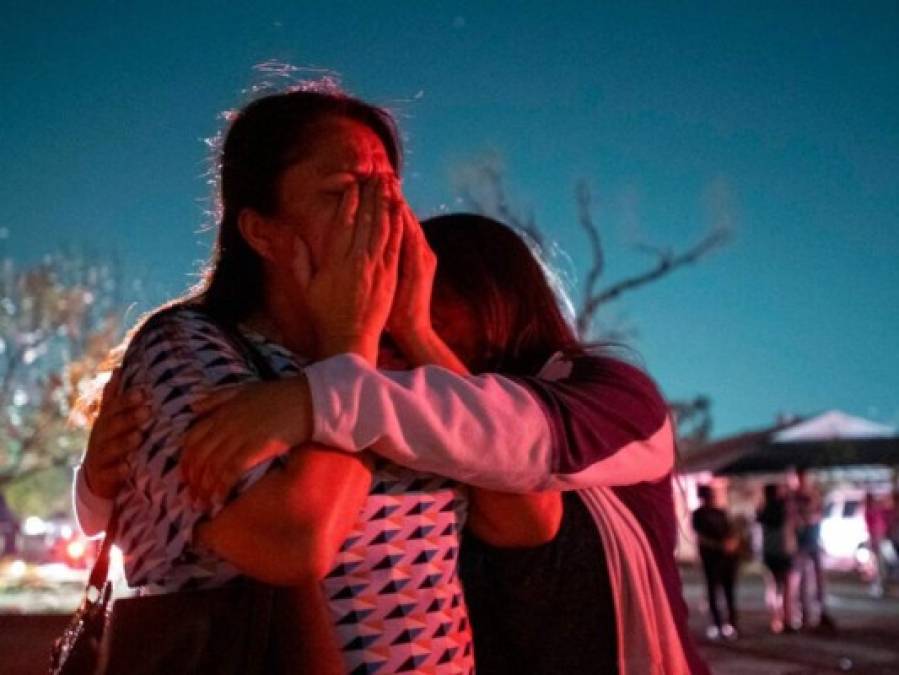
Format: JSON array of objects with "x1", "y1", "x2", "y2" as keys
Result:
[{"x1": 50, "y1": 319, "x2": 299, "y2": 675}]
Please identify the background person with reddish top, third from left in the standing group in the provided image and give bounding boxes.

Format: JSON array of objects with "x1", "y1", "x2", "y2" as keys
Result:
[{"x1": 792, "y1": 469, "x2": 836, "y2": 630}]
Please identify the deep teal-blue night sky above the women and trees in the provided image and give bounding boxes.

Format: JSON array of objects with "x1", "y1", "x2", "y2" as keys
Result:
[{"x1": 0, "y1": 1, "x2": 899, "y2": 433}]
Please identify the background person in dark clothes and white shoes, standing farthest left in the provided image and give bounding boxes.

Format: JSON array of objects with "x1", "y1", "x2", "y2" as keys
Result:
[{"x1": 692, "y1": 485, "x2": 739, "y2": 640}]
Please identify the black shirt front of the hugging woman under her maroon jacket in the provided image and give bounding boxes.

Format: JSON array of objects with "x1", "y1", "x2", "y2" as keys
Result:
[{"x1": 460, "y1": 492, "x2": 618, "y2": 675}]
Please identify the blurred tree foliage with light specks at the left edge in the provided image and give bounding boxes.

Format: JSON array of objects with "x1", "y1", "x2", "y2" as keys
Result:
[{"x1": 0, "y1": 253, "x2": 122, "y2": 515}]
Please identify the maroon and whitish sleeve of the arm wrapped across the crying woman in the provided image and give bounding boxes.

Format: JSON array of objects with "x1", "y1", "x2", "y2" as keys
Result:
[{"x1": 306, "y1": 355, "x2": 674, "y2": 492}]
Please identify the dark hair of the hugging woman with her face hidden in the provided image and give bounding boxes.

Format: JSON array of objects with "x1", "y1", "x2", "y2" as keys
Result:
[{"x1": 422, "y1": 213, "x2": 584, "y2": 375}]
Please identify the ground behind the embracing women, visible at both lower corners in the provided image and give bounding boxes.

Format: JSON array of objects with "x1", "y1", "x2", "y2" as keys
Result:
[{"x1": 0, "y1": 567, "x2": 899, "y2": 675}]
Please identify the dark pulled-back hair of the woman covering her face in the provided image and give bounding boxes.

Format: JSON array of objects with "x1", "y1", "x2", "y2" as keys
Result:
[{"x1": 204, "y1": 90, "x2": 402, "y2": 322}]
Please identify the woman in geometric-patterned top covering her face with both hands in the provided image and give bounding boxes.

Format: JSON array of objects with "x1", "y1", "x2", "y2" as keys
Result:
[{"x1": 76, "y1": 91, "x2": 564, "y2": 673}]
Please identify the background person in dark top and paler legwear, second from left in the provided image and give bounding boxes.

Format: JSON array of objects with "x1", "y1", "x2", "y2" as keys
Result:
[{"x1": 757, "y1": 483, "x2": 796, "y2": 633}]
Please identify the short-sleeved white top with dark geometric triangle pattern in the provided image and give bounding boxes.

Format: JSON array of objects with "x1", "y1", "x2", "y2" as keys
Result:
[{"x1": 116, "y1": 308, "x2": 474, "y2": 675}]
